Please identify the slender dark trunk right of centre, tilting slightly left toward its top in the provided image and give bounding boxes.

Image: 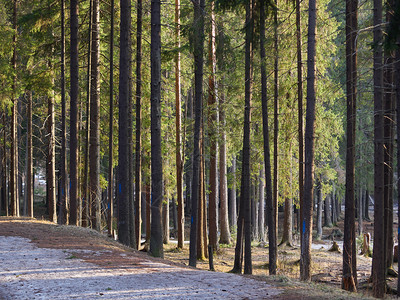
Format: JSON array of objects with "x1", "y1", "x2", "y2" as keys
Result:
[{"x1": 260, "y1": 0, "x2": 278, "y2": 275}]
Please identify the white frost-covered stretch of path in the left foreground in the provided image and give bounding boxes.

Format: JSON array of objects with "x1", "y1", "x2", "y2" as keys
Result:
[{"x1": 0, "y1": 236, "x2": 279, "y2": 300}]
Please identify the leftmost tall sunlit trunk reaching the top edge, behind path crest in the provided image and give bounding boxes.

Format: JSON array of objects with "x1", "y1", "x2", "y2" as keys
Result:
[{"x1": 10, "y1": 0, "x2": 19, "y2": 217}]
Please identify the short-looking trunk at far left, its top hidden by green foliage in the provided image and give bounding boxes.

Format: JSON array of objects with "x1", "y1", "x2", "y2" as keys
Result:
[{"x1": 26, "y1": 91, "x2": 33, "y2": 218}]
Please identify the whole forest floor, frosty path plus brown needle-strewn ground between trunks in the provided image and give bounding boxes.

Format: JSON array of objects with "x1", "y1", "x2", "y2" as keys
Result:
[{"x1": 0, "y1": 217, "x2": 392, "y2": 299}]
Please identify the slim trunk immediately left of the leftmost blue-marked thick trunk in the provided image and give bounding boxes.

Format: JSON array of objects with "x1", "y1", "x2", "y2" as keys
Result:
[{"x1": 107, "y1": 0, "x2": 115, "y2": 236}]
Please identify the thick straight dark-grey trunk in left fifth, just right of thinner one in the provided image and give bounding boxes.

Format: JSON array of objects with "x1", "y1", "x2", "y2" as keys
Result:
[{"x1": 69, "y1": 0, "x2": 79, "y2": 225}]
